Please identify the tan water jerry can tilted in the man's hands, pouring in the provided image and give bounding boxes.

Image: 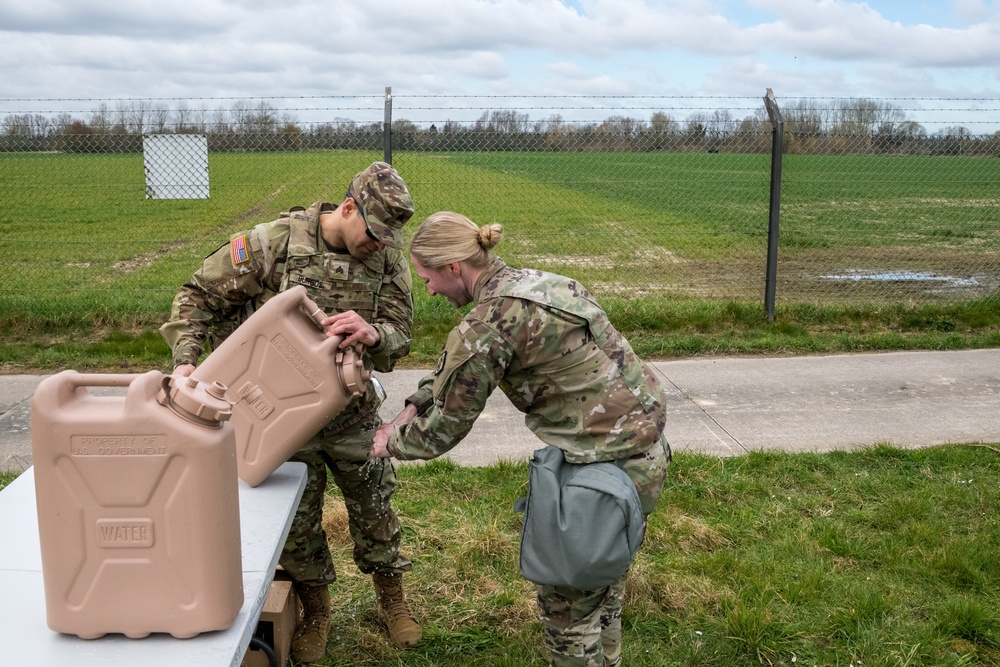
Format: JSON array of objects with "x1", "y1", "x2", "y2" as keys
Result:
[{"x1": 191, "y1": 285, "x2": 369, "y2": 486}]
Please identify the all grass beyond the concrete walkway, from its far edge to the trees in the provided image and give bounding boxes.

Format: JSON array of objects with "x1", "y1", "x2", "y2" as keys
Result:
[{"x1": 0, "y1": 151, "x2": 1000, "y2": 367}]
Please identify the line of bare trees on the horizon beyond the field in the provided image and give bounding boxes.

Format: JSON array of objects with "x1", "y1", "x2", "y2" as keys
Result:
[{"x1": 0, "y1": 99, "x2": 1000, "y2": 155}]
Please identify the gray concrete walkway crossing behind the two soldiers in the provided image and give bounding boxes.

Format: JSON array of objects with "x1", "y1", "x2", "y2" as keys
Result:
[{"x1": 0, "y1": 349, "x2": 1000, "y2": 470}]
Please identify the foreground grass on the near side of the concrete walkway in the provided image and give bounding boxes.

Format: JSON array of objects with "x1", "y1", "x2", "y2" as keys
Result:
[{"x1": 0, "y1": 446, "x2": 1000, "y2": 667}]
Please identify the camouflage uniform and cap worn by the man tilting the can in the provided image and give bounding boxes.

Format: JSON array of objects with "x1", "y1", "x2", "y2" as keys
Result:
[{"x1": 160, "y1": 163, "x2": 413, "y2": 585}]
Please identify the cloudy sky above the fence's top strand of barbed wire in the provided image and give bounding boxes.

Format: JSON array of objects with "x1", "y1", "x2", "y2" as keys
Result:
[{"x1": 0, "y1": 0, "x2": 1000, "y2": 127}]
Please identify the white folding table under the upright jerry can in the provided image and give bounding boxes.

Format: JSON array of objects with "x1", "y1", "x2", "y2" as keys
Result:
[{"x1": 0, "y1": 463, "x2": 306, "y2": 667}]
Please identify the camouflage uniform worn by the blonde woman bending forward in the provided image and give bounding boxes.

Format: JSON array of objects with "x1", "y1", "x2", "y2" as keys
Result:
[{"x1": 388, "y1": 258, "x2": 670, "y2": 666}]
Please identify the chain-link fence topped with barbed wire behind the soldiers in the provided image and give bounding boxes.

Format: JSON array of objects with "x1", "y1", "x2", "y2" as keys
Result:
[{"x1": 0, "y1": 91, "x2": 1000, "y2": 315}]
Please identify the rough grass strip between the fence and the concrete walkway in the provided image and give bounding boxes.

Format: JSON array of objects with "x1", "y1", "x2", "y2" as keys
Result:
[{"x1": 0, "y1": 298, "x2": 1000, "y2": 373}]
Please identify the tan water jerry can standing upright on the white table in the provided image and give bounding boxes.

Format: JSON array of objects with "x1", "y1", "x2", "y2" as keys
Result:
[{"x1": 31, "y1": 371, "x2": 243, "y2": 639}]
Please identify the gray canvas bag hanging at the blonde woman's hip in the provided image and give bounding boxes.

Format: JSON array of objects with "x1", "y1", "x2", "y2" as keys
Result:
[{"x1": 514, "y1": 446, "x2": 645, "y2": 591}]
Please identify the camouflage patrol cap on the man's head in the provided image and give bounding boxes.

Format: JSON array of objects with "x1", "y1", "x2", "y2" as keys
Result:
[{"x1": 347, "y1": 162, "x2": 413, "y2": 249}]
